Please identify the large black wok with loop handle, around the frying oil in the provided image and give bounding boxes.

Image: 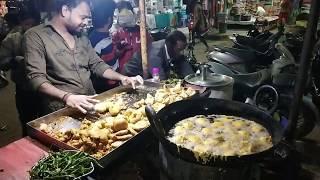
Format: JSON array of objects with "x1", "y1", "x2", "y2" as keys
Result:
[{"x1": 146, "y1": 98, "x2": 283, "y2": 166}]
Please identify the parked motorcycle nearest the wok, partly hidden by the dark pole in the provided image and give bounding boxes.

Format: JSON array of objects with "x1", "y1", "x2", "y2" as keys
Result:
[{"x1": 208, "y1": 44, "x2": 320, "y2": 137}]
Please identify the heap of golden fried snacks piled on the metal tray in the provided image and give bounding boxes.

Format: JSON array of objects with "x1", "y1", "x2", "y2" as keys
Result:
[{"x1": 40, "y1": 84, "x2": 195, "y2": 159}]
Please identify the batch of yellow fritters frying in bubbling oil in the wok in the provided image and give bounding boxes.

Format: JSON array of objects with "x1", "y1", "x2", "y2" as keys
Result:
[{"x1": 168, "y1": 115, "x2": 272, "y2": 159}]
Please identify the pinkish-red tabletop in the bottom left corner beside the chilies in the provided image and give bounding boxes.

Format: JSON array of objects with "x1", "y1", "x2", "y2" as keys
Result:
[{"x1": 0, "y1": 137, "x2": 49, "y2": 180}]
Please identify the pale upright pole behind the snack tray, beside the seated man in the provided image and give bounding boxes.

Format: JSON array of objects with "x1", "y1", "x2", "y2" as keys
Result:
[{"x1": 139, "y1": 0, "x2": 148, "y2": 78}]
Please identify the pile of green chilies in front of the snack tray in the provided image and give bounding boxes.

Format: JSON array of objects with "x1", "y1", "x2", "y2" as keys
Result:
[{"x1": 29, "y1": 151, "x2": 101, "y2": 179}]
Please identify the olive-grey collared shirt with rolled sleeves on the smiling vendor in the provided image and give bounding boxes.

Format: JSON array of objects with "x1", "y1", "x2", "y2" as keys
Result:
[{"x1": 23, "y1": 23, "x2": 109, "y2": 95}]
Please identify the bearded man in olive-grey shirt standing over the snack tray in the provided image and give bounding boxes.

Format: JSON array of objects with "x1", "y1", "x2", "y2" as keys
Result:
[{"x1": 24, "y1": 0, "x2": 143, "y2": 114}]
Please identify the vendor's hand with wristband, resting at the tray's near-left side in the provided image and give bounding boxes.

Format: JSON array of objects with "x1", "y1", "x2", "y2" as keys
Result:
[{"x1": 64, "y1": 94, "x2": 99, "y2": 114}]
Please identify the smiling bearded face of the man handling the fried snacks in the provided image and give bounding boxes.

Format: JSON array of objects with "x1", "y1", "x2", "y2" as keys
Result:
[{"x1": 62, "y1": 2, "x2": 91, "y2": 33}]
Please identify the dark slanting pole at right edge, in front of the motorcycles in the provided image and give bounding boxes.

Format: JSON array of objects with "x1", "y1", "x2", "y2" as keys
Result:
[{"x1": 285, "y1": 0, "x2": 320, "y2": 141}]
